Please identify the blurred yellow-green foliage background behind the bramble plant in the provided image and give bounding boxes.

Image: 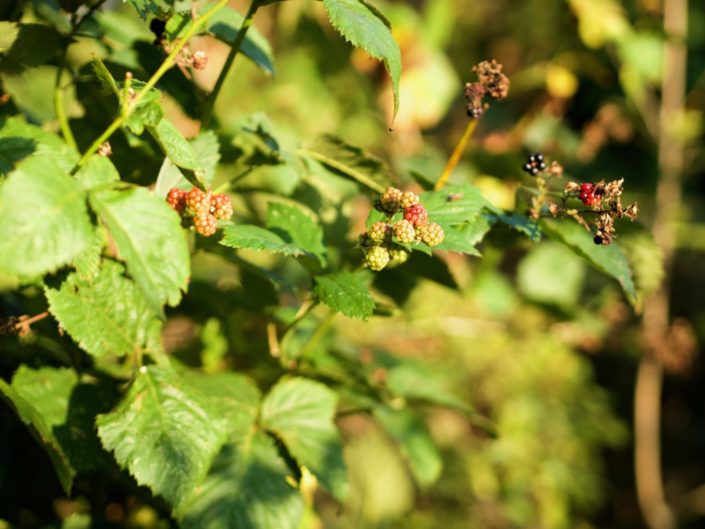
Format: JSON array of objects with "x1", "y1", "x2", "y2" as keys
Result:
[{"x1": 4, "y1": 0, "x2": 705, "y2": 529}]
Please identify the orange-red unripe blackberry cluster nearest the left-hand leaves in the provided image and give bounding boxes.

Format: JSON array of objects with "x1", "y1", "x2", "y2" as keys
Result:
[{"x1": 166, "y1": 187, "x2": 233, "y2": 237}]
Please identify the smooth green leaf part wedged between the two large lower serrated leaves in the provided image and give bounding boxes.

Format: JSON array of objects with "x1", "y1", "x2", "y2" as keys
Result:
[{"x1": 181, "y1": 369, "x2": 262, "y2": 442}]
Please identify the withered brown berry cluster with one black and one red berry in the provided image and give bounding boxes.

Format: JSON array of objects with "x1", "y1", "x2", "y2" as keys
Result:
[{"x1": 522, "y1": 153, "x2": 638, "y2": 244}]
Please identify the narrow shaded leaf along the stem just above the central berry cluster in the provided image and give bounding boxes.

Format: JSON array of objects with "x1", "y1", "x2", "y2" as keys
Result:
[{"x1": 299, "y1": 135, "x2": 392, "y2": 193}]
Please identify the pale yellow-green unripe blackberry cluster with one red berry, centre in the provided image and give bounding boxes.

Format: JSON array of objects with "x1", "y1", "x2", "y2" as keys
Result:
[{"x1": 360, "y1": 187, "x2": 445, "y2": 271}]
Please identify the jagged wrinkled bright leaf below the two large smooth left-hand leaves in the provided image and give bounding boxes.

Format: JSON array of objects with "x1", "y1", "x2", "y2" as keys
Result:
[{"x1": 46, "y1": 260, "x2": 161, "y2": 357}]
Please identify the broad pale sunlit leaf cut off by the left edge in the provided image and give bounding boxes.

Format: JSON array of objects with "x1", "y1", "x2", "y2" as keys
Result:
[{"x1": 0, "y1": 156, "x2": 93, "y2": 277}]
